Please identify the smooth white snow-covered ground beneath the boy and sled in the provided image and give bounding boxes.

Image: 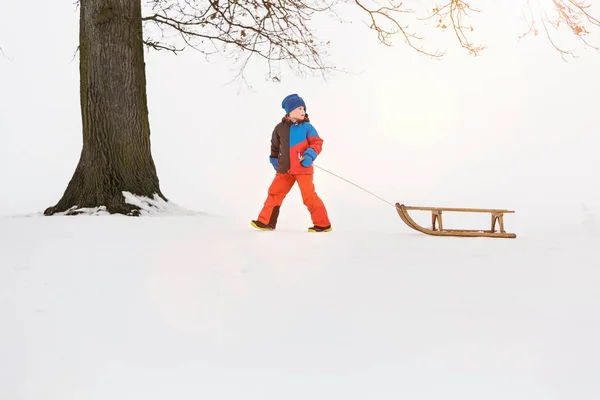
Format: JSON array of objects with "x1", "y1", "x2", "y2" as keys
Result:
[{"x1": 0, "y1": 198, "x2": 600, "y2": 400}]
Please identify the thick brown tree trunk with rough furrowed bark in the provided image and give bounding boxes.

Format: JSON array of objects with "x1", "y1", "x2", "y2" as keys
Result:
[{"x1": 44, "y1": 0, "x2": 166, "y2": 215}]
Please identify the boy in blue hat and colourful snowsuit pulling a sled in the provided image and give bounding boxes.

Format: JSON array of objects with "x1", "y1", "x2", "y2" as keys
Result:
[{"x1": 252, "y1": 93, "x2": 331, "y2": 232}]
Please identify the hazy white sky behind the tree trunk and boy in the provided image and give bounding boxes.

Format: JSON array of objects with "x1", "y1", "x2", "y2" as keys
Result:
[{"x1": 0, "y1": 0, "x2": 600, "y2": 232}]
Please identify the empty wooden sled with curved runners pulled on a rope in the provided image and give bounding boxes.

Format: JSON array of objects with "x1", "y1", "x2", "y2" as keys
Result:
[{"x1": 396, "y1": 203, "x2": 517, "y2": 239}]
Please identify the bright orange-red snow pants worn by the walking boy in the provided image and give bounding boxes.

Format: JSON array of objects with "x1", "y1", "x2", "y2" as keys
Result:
[{"x1": 258, "y1": 173, "x2": 331, "y2": 227}]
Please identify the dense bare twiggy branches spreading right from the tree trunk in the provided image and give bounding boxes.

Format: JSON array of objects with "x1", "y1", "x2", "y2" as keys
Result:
[{"x1": 143, "y1": 0, "x2": 335, "y2": 78}]
